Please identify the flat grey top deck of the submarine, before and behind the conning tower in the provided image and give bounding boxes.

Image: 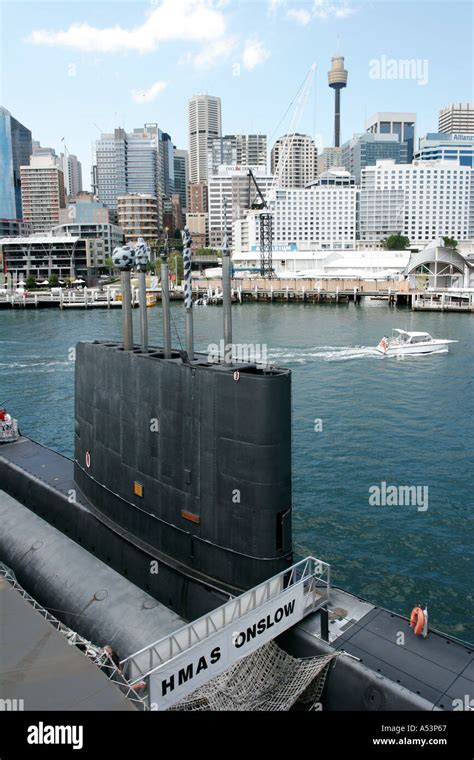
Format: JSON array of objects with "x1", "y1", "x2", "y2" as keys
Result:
[{"x1": 0, "y1": 438, "x2": 474, "y2": 710}]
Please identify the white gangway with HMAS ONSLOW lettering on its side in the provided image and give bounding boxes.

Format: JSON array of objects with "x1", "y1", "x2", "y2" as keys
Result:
[{"x1": 120, "y1": 557, "x2": 330, "y2": 710}]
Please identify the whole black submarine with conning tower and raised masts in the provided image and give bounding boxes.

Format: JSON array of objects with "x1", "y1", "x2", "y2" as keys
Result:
[{"x1": 0, "y1": 230, "x2": 474, "y2": 711}]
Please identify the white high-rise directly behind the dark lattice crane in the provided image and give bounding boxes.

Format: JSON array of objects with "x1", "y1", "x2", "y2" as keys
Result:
[{"x1": 209, "y1": 166, "x2": 273, "y2": 248}]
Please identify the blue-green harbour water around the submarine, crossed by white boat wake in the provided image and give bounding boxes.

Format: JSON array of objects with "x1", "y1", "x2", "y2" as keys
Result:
[{"x1": 0, "y1": 300, "x2": 474, "y2": 641}]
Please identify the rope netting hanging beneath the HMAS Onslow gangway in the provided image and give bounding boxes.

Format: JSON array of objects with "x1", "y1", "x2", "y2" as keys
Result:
[{"x1": 170, "y1": 641, "x2": 337, "y2": 711}]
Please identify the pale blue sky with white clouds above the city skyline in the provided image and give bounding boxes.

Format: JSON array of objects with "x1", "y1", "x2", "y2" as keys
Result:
[{"x1": 0, "y1": 0, "x2": 474, "y2": 189}]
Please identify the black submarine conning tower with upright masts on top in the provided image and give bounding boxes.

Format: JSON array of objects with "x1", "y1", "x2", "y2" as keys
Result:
[{"x1": 74, "y1": 232, "x2": 292, "y2": 607}]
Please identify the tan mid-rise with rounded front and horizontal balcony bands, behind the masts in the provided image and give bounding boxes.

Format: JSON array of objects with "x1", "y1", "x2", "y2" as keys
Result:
[{"x1": 117, "y1": 193, "x2": 160, "y2": 247}]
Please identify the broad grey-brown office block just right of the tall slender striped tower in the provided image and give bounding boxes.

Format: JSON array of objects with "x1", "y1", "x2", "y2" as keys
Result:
[{"x1": 208, "y1": 134, "x2": 267, "y2": 174}]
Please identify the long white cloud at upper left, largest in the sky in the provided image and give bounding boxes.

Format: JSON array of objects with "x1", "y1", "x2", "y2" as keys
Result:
[{"x1": 27, "y1": 0, "x2": 226, "y2": 53}]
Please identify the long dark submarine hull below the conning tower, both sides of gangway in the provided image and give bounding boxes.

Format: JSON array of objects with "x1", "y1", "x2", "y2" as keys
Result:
[{"x1": 0, "y1": 438, "x2": 474, "y2": 711}]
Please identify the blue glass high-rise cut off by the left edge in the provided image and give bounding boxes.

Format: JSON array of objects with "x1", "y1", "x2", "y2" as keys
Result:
[{"x1": 0, "y1": 106, "x2": 32, "y2": 219}]
